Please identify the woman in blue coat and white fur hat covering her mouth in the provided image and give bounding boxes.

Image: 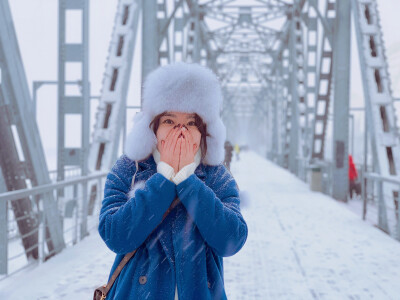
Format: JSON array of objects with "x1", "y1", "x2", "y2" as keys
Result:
[{"x1": 99, "y1": 63, "x2": 247, "y2": 300}]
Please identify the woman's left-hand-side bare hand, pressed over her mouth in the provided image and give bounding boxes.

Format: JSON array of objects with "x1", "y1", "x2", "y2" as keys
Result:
[{"x1": 160, "y1": 127, "x2": 182, "y2": 174}]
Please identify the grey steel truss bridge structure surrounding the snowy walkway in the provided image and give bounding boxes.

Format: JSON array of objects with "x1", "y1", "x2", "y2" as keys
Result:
[{"x1": 0, "y1": 0, "x2": 400, "y2": 274}]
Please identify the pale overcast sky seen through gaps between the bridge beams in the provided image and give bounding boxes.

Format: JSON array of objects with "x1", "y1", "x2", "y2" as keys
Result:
[{"x1": 9, "y1": 0, "x2": 400, "y2": 169}]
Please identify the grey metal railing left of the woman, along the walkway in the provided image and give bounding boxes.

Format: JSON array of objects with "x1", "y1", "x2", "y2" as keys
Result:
[{"x1": 0, "y1": 172, "x2": 108, "y2": 280}]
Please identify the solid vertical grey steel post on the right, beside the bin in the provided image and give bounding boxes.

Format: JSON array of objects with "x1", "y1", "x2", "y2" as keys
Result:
[{"x1": 332, "y1": 1, "x2": 351, "y2": 201}]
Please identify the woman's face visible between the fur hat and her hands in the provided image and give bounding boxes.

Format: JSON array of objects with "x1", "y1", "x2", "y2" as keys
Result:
[{"x1": 156, "y1": 112, "x2": 201, "y2": 152}]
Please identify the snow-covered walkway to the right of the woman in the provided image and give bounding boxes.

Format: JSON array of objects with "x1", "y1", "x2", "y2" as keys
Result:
[{"x1": 224, "y1": 152, "x2": 400, "y2": 299}]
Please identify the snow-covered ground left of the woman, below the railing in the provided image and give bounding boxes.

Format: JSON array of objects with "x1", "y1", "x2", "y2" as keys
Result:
[{"x1": 0, "y1": 227, "x2": 114, "y2": 300}]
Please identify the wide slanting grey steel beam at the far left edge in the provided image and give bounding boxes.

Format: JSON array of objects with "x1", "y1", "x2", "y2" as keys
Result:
[{"x1": 0, "y1": 1, "x2": 65, "y2": 259}]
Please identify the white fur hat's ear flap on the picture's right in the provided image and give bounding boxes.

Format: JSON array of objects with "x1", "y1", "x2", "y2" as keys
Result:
[{"x1": 204, "y1": 118, "x2": 226, "y2": 166}]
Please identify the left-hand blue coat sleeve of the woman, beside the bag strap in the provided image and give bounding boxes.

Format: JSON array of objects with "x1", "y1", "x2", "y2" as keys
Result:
[{"x1": 98, "y1": 156, "x2": 176, "y2": 254}]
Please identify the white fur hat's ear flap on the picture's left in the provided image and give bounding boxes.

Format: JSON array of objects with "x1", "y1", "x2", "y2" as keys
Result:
[{"x1": 124, "y1": 111, "x2": 157, "y2": 160}]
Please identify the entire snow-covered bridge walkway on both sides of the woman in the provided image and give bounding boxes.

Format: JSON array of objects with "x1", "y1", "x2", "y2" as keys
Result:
[{"x1": 0, "y1": 152, "x2": 400, "y2": 300}]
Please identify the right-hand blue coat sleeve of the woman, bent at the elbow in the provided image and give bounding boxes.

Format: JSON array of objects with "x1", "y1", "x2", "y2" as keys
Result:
[{"x1": 177, "y1": 164, "x2": 248, "y2": 256}]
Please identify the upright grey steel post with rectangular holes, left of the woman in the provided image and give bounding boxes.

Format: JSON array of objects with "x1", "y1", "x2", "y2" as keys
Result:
[{"x1": 57, "y1": 0, "x2": 90, "y2": 196}]
